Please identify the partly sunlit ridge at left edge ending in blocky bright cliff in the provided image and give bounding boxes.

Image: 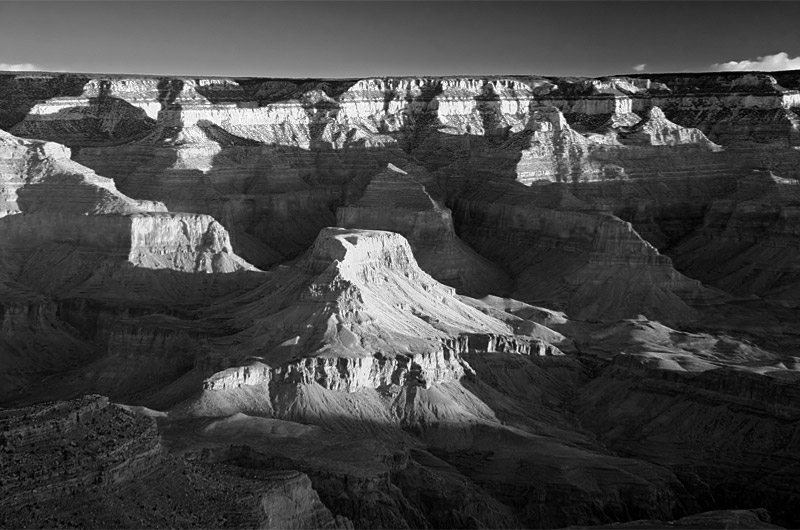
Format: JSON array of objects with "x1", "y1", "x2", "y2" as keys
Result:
[{"x1": 0, "y1": 127, "x2": 252, "y2": 282}]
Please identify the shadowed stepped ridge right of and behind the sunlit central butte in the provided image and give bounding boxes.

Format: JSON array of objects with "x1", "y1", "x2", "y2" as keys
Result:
[{"x1": 450, "y1": 182, "x2": 714, "y2": 322}]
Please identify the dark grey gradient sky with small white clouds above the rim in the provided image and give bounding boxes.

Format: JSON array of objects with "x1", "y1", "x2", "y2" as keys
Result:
[{"x1": 0, "y1": 0, "x2": 800, "y2": 77}]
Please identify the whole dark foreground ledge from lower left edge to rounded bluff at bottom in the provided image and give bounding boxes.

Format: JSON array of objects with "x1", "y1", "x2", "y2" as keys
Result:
[{"x1": 0, "y1": 396, "x2": 353, "y2": 529}]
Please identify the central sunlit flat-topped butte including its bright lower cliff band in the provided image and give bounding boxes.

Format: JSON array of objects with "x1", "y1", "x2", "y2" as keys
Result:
[{"x1": 184, "y1": 228, "x2": 544, "y2": 406}]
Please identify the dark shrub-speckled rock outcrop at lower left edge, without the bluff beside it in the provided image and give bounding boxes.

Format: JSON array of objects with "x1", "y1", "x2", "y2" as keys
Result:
[{"x1": 0, "y1": 396, "x2": 162, "y2": 512}]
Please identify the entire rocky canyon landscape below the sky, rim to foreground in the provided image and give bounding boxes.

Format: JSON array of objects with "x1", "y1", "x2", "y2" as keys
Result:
[{"x1": 0, "y1": 72, "x2": 800, "y2": 528}]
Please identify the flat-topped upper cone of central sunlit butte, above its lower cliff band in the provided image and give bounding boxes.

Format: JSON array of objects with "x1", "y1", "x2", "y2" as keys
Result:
[{"x1": 198, "y1": 228, "x2": 529, "y2": 374}]
